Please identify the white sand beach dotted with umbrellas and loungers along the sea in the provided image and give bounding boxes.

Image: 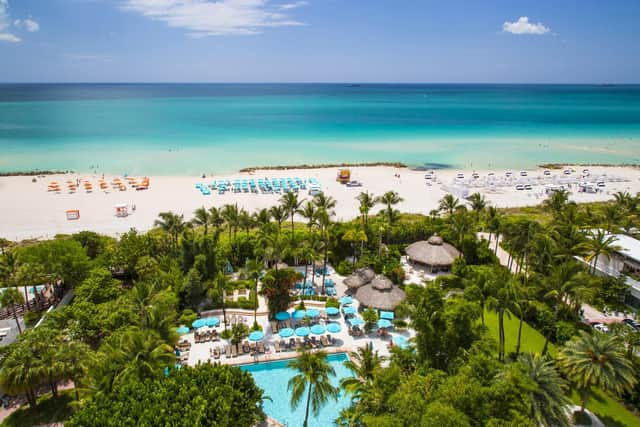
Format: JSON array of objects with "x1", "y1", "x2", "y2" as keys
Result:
[{"x1": 0, "y1": 166, "x2": 640, "y2": 241}]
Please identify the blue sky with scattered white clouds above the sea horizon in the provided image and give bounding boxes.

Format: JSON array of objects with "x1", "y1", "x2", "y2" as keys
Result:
[{"x1": 0, "y1": 0, "x2": 640, "y2": 83}]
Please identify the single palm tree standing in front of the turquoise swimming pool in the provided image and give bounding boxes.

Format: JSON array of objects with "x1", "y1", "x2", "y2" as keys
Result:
[{"x1": 287, "y1": 351, "x2": 338, "y2": 427}]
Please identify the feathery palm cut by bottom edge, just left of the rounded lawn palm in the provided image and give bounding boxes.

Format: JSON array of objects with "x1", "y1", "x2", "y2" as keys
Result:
[{"x1": 518, "y1": 353, "x2": 573, "y2": 427}]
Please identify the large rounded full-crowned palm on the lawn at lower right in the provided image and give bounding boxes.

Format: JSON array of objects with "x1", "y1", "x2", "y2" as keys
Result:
[{"x1": 558, "y1": 331, "x2": 637, "y2": 412}]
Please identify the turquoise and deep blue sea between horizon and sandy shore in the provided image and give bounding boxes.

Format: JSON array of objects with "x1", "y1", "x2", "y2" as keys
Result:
[{"x1": 0, "y1": 84, "x2": 640, "y2": 175}]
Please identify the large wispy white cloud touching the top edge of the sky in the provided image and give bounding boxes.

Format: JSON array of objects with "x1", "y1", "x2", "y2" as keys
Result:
[{"x1": 123, "y1": 0, "x2": 304, "y2": 37}]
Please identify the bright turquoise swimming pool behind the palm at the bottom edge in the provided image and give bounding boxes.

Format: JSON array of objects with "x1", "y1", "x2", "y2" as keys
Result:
[{"x1": 240, "y1": 353, "x2": 351, "y2": 427}]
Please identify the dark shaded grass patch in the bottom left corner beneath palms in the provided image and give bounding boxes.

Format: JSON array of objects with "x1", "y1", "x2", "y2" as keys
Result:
[{"x1": 2, "y1": 390, "x2": 73, "y2": 427}]
